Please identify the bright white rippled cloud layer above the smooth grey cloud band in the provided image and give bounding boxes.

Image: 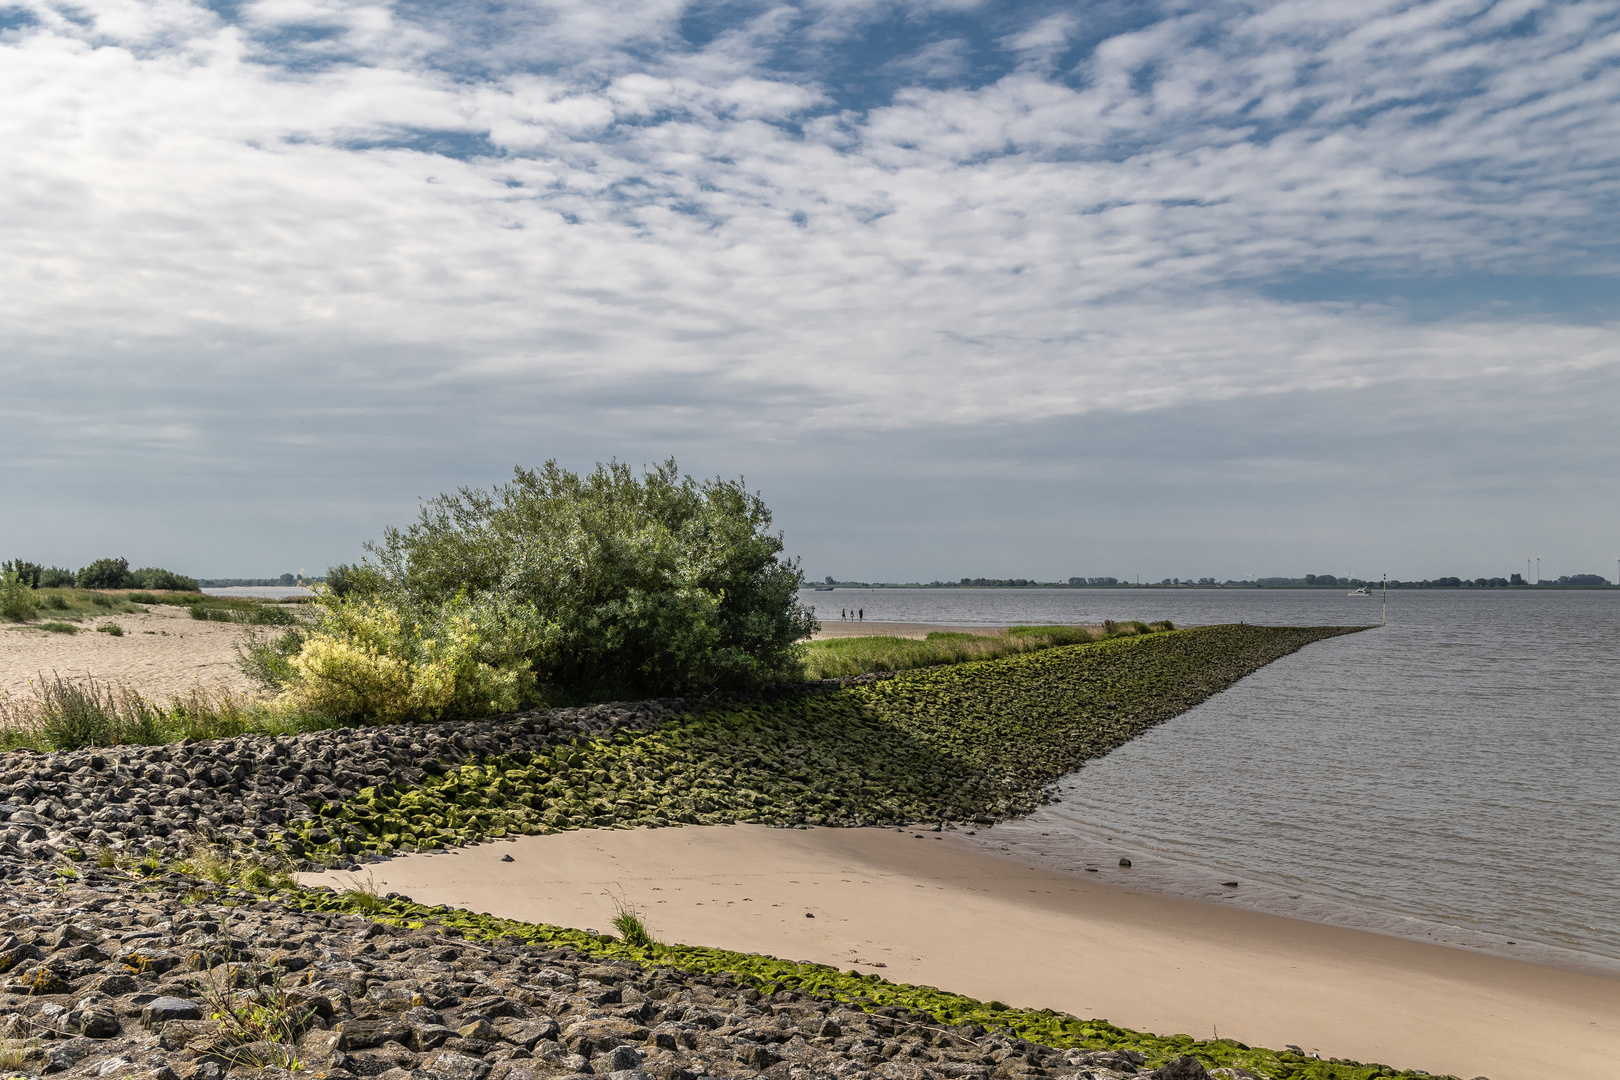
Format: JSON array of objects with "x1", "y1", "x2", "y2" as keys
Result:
[{"x1": 0, "y1": 0, "x2": 1620, "y2": 531}]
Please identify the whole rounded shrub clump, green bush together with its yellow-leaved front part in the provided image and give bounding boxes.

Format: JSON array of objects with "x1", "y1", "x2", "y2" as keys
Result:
[{"x1": 272, "y1": 460, "x2": 815, "y2": 719}]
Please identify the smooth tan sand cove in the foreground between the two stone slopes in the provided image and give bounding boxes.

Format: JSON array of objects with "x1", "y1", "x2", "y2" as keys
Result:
[{"x1": 305, "y1": 826, "x2": 1620, "y2": 1080}]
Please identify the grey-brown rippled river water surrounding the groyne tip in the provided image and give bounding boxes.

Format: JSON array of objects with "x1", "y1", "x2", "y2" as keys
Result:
[{"x1": 804, "y1": 589, "x2": 1620, "y2": 975}]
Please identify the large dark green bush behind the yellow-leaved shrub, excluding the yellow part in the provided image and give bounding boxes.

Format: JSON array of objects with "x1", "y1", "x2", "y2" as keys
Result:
[{"x1": 349, "y1": 460, "x2": 816, "y2": 695}]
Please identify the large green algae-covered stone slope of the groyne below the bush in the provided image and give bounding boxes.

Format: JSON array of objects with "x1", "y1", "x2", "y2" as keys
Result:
[{"x1": 288, "y1": 627, "x2": 1353, "y2": 861}]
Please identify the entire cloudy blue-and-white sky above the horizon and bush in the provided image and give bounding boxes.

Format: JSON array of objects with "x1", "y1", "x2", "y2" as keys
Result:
[{"x1": 0, "y1": 0, "x2": 1620, "y2": 581}]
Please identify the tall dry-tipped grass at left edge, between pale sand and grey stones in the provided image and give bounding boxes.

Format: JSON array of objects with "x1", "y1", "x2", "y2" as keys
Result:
[{"x1": 0, "y1": 674, "x2": 337, "y2": 751}]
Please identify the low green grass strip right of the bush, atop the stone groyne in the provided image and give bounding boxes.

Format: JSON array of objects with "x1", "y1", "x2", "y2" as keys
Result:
[{"x1": 805, "y1": 622, "x2": 1173, "y2": 678}]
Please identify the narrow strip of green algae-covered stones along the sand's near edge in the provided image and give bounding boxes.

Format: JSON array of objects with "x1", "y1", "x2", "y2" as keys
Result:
[{"x1": 279, "y1": 889, "x2": 1443, "y2": 1080}]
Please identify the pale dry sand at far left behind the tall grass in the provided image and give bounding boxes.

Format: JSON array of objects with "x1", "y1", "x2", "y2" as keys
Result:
[{"x1": 0, "y1": 606, "x2": 265, "y2": 699}]
